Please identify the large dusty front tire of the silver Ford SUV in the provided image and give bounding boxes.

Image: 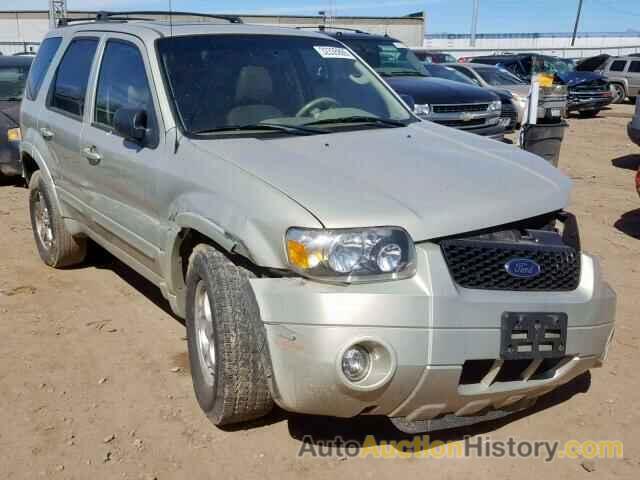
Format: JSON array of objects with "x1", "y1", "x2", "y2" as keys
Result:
[{"x1": 186, "y1": 244, "x2": 273, "y2": 426}]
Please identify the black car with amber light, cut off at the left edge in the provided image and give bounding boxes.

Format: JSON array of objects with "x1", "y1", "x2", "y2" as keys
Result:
[{"x1": 0, "y1": 56, "x2": 33, "y2": 176}]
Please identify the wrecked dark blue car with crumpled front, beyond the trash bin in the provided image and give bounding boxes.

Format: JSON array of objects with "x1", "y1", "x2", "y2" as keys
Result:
[{"x1": 472, "y1": 54, "x2": 613, "y2": 117}]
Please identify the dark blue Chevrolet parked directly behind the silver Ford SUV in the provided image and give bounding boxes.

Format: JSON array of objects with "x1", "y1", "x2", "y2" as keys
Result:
[{"x1": 324, "y1": 29, "x2": 505, "y2": 139}]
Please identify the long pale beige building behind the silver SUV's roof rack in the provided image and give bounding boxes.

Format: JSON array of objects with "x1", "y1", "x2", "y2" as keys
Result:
[{"x1": 0, "y1": 10, "x2": 424, "y2": 55}]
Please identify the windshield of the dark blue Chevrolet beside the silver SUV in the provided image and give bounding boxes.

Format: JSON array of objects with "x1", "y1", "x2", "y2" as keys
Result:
[{"x1": 341, "y1": 38, "x2": 428, "y2": 77}]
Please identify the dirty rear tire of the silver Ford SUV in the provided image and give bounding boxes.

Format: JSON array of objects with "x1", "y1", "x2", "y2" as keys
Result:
[{"x1": 29, "y1": 171, "x2": 87, "y2": 268}]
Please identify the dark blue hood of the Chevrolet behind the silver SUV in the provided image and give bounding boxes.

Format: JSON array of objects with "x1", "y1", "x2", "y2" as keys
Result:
[{"x1": 384, "y1": 77, "x2": 497, "y2": 104}]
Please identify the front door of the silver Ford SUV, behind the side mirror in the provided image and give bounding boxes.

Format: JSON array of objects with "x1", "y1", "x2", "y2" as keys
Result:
[{"x1": 80, "y1": 34, "x2": 164, "y2": 271}]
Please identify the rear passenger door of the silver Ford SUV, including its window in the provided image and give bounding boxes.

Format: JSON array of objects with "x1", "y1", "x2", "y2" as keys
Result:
[{"x1": 38, "y1": 35, "x2": 100, "y2": 202}]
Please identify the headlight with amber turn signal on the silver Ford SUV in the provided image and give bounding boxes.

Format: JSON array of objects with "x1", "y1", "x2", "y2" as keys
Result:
[{"x1": 286, "y1": 227, "x2": 416, "y2": 283}]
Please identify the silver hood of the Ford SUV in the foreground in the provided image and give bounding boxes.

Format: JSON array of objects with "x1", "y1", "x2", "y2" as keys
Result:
[{"x1": 190, "y1": 122, "x2": 570, "y2": 241}]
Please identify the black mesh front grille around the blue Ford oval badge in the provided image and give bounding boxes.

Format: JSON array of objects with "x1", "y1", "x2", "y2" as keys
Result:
[{"x1": 440, "y1": 239, "x2": 580, "y2": 292}]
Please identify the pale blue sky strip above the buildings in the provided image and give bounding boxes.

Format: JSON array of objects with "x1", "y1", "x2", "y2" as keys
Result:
[{"x1": 0, "y1": 0, "x2": 640, "y2": 33}]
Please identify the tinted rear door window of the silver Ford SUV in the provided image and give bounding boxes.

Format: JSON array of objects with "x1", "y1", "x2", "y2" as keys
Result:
[{"x1": 50, "y1": 38, "x2": 98, "y2": 117}]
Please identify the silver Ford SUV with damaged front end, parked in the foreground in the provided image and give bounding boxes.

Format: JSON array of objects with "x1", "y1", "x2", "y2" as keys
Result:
[{"x1": 21, "y1": 17, "x2": 616, "y2": 431}]
